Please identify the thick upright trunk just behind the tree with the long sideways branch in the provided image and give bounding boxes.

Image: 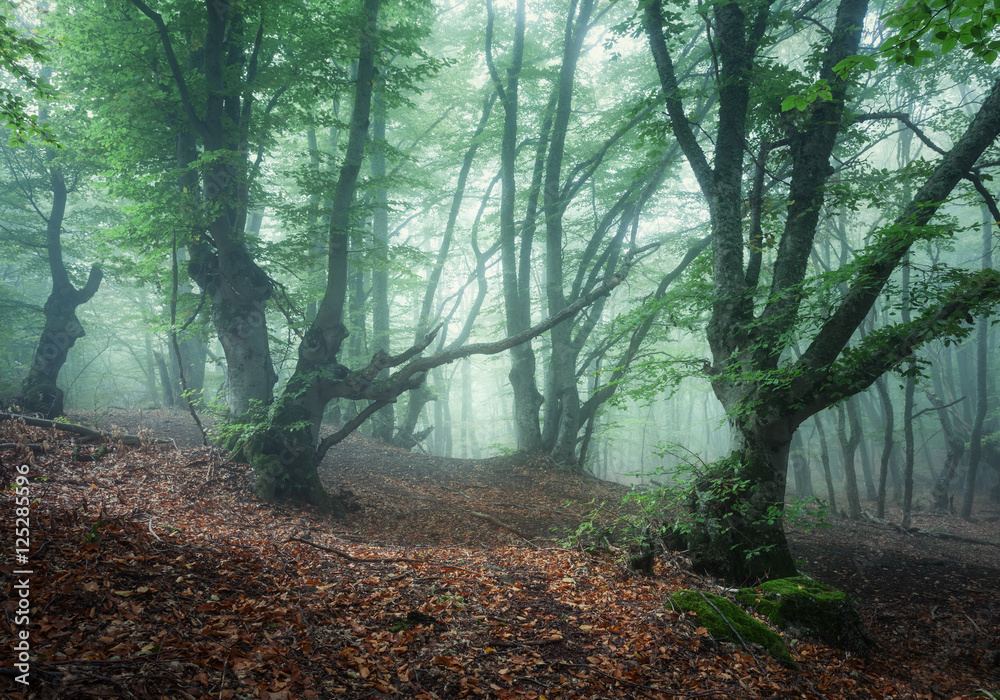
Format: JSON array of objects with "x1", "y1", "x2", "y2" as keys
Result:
[{"x1": 123, "y1": 0, "x2": 287, "y2": 417}]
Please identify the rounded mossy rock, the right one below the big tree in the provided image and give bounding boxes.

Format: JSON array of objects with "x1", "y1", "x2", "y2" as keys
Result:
[{"x1": 736, "y1": 576, "x2": 868, "y2": 656}]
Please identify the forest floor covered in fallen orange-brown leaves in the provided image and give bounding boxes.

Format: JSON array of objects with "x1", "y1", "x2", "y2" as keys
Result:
[{"x1": 0, "y1": 411, "x2": 1000, "y2": 700}]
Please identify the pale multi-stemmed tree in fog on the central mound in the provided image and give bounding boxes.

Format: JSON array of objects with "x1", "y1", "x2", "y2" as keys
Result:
[{"x1": 485, "y1": 2, "x2": 698, "y2": 467}]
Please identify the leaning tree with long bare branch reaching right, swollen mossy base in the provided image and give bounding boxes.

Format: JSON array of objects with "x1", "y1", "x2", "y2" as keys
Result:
[{"x1": 246, "y1": 0, "x2": 627, "y2": 504}]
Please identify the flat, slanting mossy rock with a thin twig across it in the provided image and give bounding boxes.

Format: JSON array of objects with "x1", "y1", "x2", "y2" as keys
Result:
[{"x1": 667, "y1": 591, "x2": 796, "y2": 668}]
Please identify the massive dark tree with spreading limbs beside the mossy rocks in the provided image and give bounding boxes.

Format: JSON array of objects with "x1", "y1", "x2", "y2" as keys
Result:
[{"x1": 641, "y1": 0, "x2": 1000, "y2": 582}]
